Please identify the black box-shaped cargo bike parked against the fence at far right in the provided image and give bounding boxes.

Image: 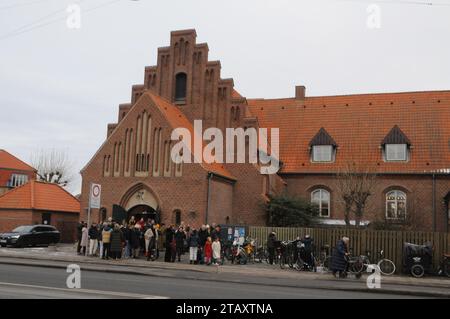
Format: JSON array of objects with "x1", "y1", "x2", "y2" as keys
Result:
[{"x1": 403, "y1": 243, "x2": 433, "y2": 278}]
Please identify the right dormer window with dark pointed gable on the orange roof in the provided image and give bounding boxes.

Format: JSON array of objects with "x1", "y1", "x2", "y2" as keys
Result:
[{"x1": 381, "y1": 125, "x2": 411, "y2": 162}]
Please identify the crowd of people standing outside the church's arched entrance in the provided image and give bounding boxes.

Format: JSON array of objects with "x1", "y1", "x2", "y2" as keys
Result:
[{"x1": 77, "y1": 217, "x2": 222, "y2": 265}]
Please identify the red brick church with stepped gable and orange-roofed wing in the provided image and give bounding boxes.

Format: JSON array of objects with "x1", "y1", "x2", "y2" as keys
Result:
[{"x1": 81, "y1": 30, "x2": 450, "y2": 231}]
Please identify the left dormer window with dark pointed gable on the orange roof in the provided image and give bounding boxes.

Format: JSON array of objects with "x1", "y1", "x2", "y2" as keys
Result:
[{"x1": 309, "y1": 127, "x2": 337, "y2": 163}]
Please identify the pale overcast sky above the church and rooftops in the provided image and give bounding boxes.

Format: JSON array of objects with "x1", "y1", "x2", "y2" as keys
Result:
[{"x1": 0, "y1": 0, "x2": 450, "y2": 193}]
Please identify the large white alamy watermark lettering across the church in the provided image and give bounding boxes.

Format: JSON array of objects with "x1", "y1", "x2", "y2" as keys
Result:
[{"x1": 170, "y1": 120, "x2": 280, "y2": 174}]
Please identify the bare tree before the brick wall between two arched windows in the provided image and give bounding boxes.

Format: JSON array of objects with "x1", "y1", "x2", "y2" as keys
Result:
[{"x1": 336, "y1": 163, "x2": 377, "y2": 227}]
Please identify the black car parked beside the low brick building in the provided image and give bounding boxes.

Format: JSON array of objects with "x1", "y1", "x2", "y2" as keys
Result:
[{"x1": 0, "y1": 225, "x2": 61, "y2": 247}]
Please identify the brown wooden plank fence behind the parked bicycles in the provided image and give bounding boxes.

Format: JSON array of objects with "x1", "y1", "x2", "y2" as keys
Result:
[{"x1": 248, "y1": 226, "x2": 450, "y2": 271}]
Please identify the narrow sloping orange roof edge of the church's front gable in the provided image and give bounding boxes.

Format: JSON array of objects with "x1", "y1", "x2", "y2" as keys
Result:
[{"x1": 144, "y1": 91, "x2": 236, "y2": 180}]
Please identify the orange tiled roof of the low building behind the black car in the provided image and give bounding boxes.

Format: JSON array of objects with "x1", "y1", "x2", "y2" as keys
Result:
[{"x1": 0, "y1": 181, "x2": 80, "y2": 213}]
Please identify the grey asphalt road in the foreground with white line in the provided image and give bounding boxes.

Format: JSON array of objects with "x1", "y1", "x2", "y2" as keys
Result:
[{"x1": 0, "y1": 264, "x2": 424, "y2": 299}]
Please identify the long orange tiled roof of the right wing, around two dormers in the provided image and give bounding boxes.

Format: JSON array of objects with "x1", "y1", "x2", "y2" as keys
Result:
[{"x1": 248, "y1": 91, "x2": 450, "y2": 173}]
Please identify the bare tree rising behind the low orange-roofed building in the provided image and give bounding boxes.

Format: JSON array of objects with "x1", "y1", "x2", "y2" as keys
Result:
[{"x1": 31, "y1": 149, "x2": 74, "y2": 187}]
